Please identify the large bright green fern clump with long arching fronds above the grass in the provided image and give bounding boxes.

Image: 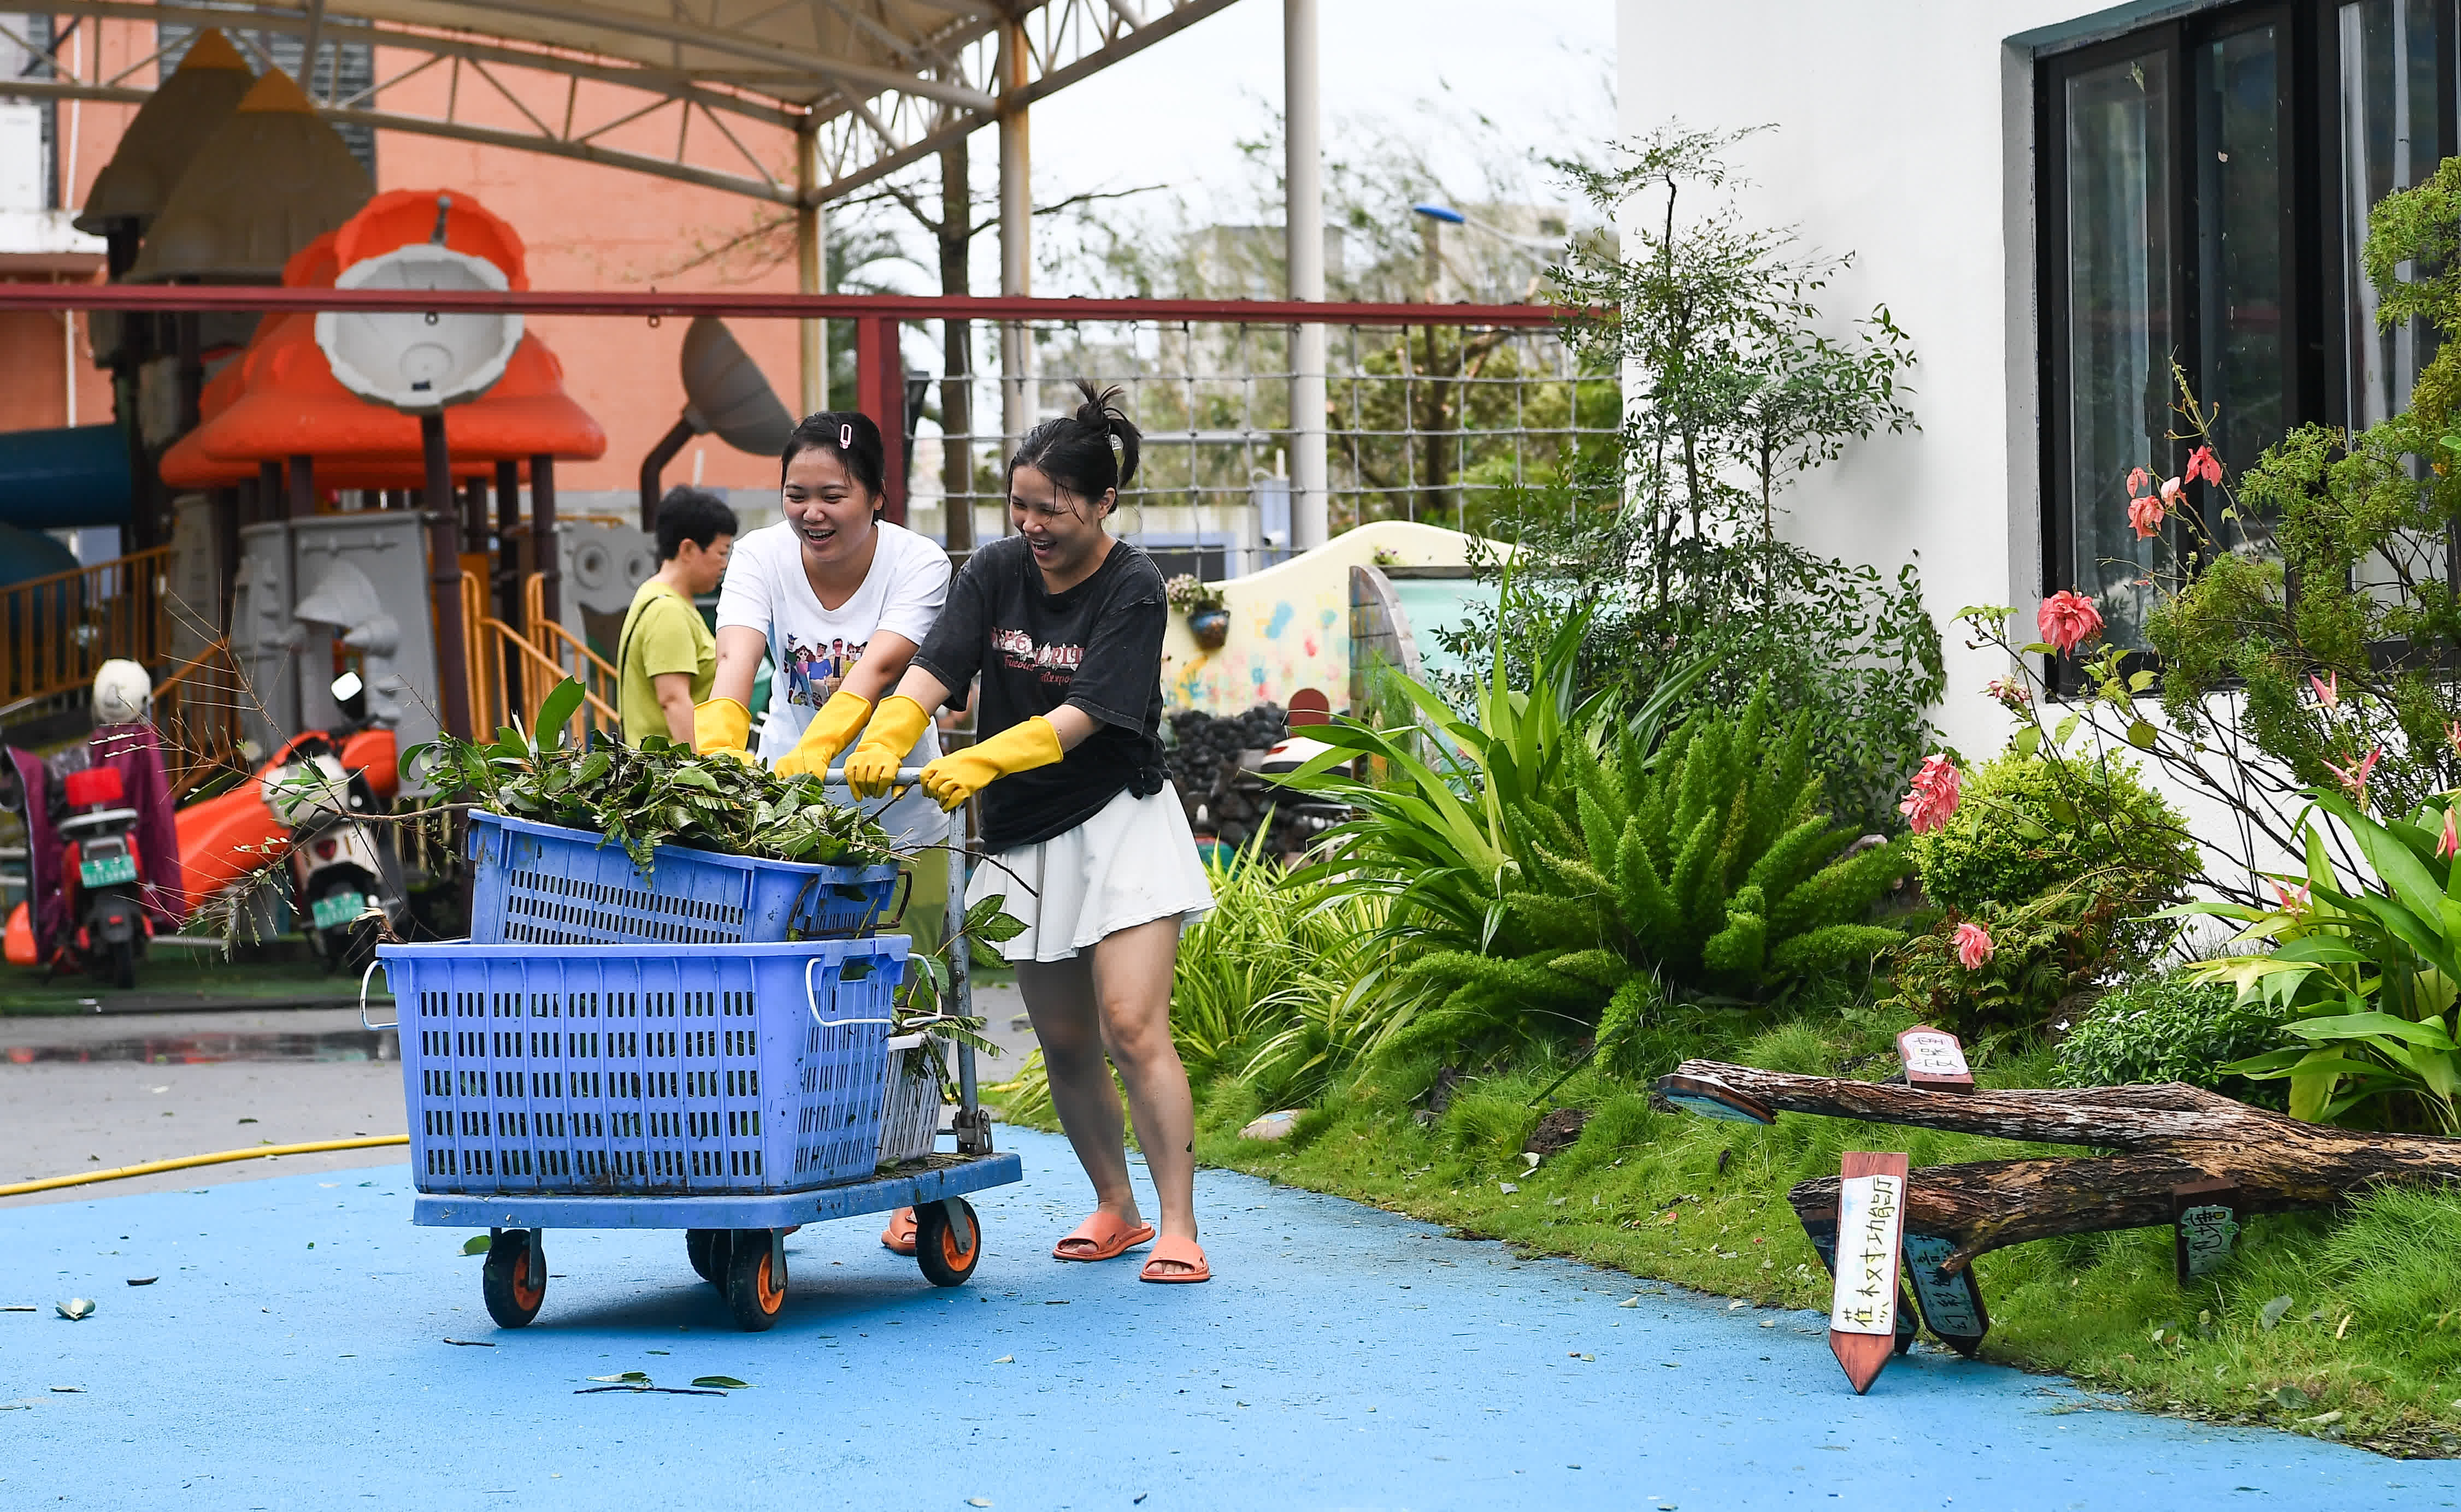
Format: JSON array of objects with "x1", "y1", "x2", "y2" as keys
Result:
[{"x1": 1290, "y1": 627, "x2": 1912, "y2": 1067}]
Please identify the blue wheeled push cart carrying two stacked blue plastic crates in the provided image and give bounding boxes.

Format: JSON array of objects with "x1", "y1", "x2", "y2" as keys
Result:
[{"x1": 362, "y1": 772, "x2": 1021, "y2": 1330}]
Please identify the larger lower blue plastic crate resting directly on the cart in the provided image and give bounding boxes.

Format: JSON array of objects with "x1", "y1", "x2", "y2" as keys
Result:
[{"x1": 376, "y1": 934, "x2": 908, "y2": 1195}]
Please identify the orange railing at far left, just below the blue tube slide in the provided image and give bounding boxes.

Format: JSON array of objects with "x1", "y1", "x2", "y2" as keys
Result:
[{"x1": 0, "y1": 546, "x2": 170, "y2": 713}]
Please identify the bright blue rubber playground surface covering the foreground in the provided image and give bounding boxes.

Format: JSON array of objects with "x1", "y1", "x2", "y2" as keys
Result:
[{"x1": 0, "y1": 1129, "x2": 2461, "y2": 1512}]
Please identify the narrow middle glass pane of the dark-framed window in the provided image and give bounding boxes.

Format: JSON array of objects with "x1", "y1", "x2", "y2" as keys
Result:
[{"x1": 2195, "y1": 25, "x2": 2291, "y2": 546}]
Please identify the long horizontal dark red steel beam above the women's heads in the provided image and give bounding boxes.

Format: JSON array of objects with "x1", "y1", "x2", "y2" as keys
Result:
[{"x1": 0, "y1": 283, "x2": 1580, "y2": 327}]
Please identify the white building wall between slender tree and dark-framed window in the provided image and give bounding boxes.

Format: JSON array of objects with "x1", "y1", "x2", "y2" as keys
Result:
[{"x1": 1617, "y1": 0, "x2": 2191, "y2": 757}]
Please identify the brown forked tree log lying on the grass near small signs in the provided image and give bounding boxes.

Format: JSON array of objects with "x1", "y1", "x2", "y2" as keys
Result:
[{"x1": 1661, "y1": 1060, "x2": 2461, "y2": 1273}]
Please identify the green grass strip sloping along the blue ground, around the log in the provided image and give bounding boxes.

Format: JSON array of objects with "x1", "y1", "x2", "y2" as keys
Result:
[{"x1": 994, "y1": 1020, "x2": 2461, "y2": 1455}]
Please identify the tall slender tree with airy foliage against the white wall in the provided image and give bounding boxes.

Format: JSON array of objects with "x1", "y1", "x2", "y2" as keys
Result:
[{"x1": 1437, "y1": 128, "x2": 1944, "y2": 829}]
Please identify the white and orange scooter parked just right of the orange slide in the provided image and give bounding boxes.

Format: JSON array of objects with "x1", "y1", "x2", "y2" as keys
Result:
[{"x1": 261, "y1": 671, "x2": 411, "y2": 971}]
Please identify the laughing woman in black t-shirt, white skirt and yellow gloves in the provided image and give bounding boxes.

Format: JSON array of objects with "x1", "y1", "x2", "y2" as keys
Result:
[{"x1": 846, "y1": 383, "x2": 1213, "y2": 1281}]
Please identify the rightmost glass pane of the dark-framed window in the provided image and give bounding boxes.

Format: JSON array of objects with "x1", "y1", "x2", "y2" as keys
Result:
[{"x1": 2340, "y1": 0, "x2": 2444, "y2": 430}]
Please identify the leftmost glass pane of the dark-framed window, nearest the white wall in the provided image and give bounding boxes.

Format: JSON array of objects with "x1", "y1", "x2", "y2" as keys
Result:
[{"x1": 2062, "y1": 52, "x2": 2176, "y2": 647}]
